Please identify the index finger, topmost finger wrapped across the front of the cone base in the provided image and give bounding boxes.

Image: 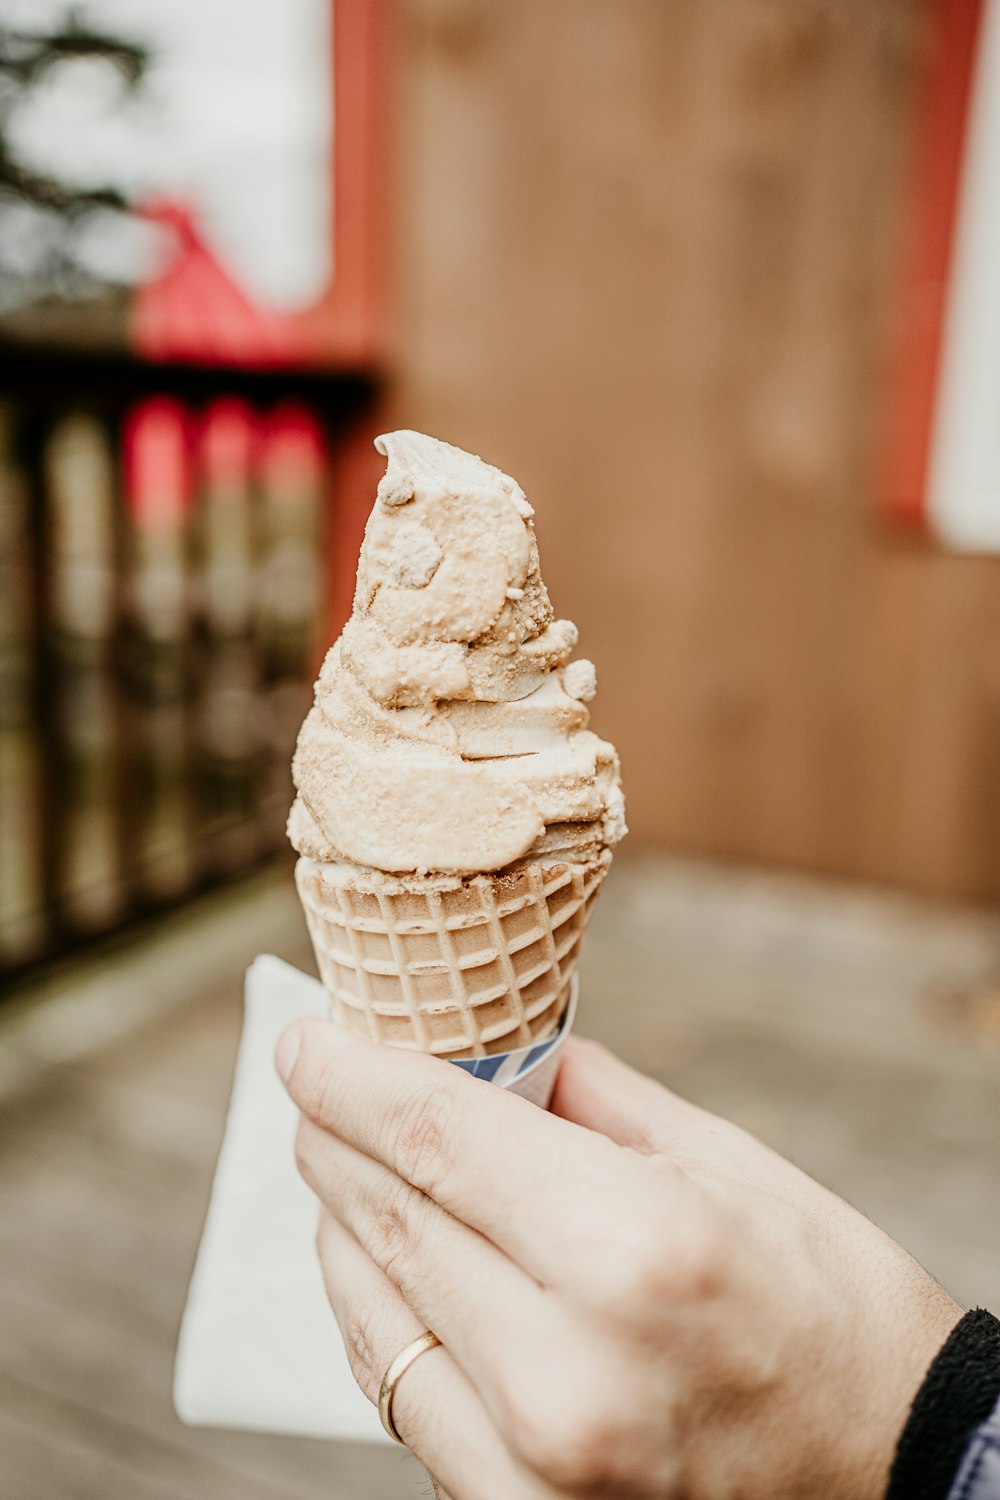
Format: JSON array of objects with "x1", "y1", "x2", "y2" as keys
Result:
[{"x1": 276, "y1": 1020, "x2": 621, "y2": 1286}]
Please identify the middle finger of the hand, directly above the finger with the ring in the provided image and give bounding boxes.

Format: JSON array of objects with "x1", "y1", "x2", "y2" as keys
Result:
[{"x1": 295, "y1": 1118, "x2": 556, "y2": 1415}]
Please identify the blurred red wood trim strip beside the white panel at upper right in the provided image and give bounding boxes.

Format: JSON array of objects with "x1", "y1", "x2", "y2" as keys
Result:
[{"x1": 880, "y1": 0, "x2": 984, "y2": 527}]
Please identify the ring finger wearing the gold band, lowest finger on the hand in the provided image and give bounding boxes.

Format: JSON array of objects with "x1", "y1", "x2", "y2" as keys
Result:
[{"x1": 318, "y1": 1214, "x2": 541, "y2": 1500}]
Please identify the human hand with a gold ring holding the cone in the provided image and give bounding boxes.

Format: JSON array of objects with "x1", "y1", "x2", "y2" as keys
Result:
[{"x1": 277, "y1": 1022, "x2": 961, "y2": 1500}]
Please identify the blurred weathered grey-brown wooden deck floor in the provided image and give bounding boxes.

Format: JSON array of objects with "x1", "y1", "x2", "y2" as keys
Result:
[{"x1": 0, "y1": 857, "x2": 1000, "y2": 1500}]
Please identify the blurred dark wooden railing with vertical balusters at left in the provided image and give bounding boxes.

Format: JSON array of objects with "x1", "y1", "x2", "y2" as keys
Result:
[{"x1": 0, "y1": 362, "x2": 374, "y2": 972}]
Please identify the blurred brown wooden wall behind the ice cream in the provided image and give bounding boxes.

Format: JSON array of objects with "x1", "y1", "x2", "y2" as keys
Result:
[{"x1": 380, "y1": 0, "x2": 1000, "y2": 897}]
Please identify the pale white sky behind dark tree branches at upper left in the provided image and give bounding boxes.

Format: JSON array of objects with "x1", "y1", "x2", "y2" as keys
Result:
[{"x1": 0, "y1": 0, "x2": 333, "y2": 309}]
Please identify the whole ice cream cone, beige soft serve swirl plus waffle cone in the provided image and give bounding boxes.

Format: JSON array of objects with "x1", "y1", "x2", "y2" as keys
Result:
[{"x1": 288, "y1": 431, "x2": 625, "y2": 1073}]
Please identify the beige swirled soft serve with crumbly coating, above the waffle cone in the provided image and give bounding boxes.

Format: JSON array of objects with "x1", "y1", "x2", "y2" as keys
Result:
[{"x1": 288, "y1": 431, "x2": 625, "y2": 875}]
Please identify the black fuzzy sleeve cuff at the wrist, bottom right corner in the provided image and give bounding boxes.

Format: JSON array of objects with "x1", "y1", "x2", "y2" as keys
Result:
[{"x1": 886, "y1": 1308, "x2": 1000, "y2": 1500}]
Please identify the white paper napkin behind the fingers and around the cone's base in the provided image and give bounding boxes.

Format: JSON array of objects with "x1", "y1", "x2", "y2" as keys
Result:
[{"x1": 174, "y1": 956, "x2": 576, "y2": 1443}]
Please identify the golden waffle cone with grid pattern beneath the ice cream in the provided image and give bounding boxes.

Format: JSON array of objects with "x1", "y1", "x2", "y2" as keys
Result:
[{"x1": 295, "y1": 854, "x2": 610, "y2": 1058}]
